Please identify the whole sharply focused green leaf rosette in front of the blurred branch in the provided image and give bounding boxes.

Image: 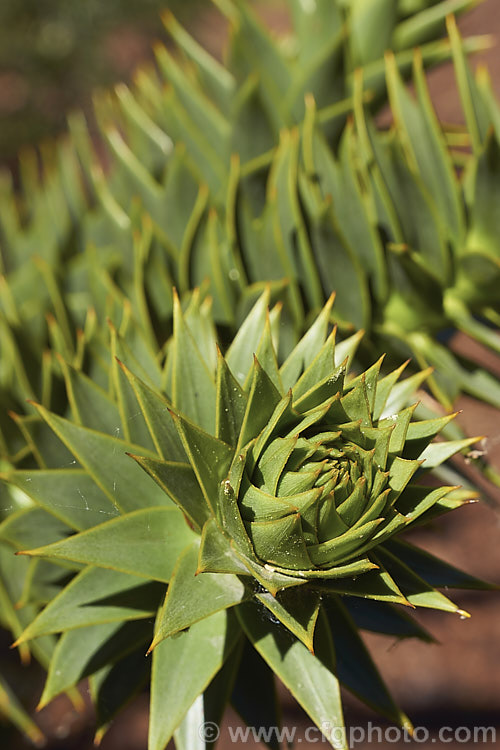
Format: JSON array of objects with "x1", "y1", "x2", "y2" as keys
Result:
[{"x1": 4, "y1": 290, "x2": 487, "y2": 750}]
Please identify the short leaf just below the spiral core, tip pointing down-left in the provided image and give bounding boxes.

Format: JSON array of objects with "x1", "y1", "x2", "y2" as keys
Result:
[{"x1": 151, "y1": 540, "x2": 251, "y2": 649}]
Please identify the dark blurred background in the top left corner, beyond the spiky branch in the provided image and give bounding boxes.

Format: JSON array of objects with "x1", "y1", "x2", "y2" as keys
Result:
[{"x1": 0, "y1": 0, "x2": 198, "y2": 163}]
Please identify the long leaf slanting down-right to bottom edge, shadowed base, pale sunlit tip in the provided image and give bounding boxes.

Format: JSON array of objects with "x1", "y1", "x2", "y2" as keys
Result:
[{"x1": 237, "y1": 602, "x2": 347, "y2": 750}]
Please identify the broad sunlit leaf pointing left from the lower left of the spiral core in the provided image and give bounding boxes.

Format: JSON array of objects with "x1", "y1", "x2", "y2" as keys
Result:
[{"x1": 23, "y1": 508, "x2": 196, "y2": 582}]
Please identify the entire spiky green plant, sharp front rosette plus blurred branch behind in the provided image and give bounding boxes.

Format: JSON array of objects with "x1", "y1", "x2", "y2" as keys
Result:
[{"x1": 0, "y1": 0, "x2": 500, "y2": 749}]
